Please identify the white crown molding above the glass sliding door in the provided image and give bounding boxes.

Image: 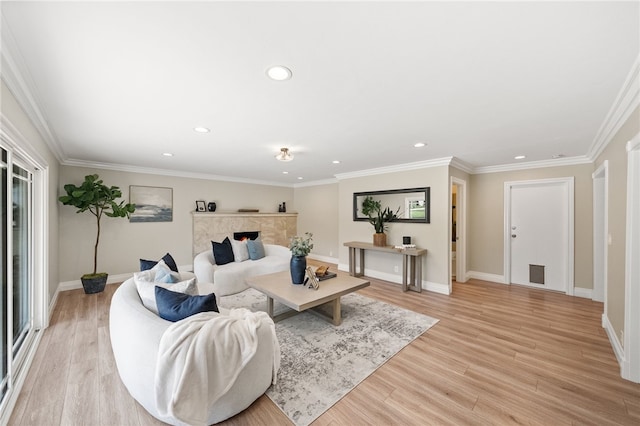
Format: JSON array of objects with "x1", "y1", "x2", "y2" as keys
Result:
[{"x1": 0, "y1": 9, "x2": 66, "y2": 162}]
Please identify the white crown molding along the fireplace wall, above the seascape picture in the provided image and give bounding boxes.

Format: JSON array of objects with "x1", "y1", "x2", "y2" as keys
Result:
[{"x1": 61, "y1": 159, "x2": 293, "y2": 188}]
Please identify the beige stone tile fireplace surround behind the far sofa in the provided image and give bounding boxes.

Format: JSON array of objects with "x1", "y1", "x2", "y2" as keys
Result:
[{"x1": 192, "y1": 212, "x2": 298, "y2": 256}]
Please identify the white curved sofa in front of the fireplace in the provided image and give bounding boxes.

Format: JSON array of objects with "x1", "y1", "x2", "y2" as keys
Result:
[{"x1": 193, "y1": 244, "x2": 291, "y2": 296}]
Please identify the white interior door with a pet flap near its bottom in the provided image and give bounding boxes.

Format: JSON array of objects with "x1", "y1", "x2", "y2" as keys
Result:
[{"x1": 506, "y1": 180, "x2": 573, "y2": 294}]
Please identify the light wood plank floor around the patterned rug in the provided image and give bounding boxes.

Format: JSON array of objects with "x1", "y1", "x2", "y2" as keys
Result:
[{"x1": 10, "y1": 274, "x2": 640, "y2": 426}]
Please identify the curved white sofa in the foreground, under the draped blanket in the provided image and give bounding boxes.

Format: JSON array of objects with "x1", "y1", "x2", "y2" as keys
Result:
[{"x1": 109, "y1": 278, "x2": 279, "y2": 425}]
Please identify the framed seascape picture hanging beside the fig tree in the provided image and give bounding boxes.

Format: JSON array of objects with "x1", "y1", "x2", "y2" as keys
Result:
[{"x1": 129, "y1": 185, "x2": 173, "y2": 222}]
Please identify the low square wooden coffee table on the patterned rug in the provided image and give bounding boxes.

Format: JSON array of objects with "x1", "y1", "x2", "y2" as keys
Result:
[{"x1": 247, "y1": 271, "x2": 369, "y2": 325}]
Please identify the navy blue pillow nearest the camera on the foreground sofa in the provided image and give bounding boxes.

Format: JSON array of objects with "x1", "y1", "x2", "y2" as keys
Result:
[{"x1": 155, "y1": 286, "x2": 219, "y2": 322}]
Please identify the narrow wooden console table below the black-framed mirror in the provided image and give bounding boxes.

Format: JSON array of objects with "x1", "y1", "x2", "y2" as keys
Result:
[{"x1": 344, "y1": 241, "x2": 427, "y2": 293}]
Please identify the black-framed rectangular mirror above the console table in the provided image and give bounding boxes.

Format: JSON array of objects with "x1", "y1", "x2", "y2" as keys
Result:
[{"x1": 353, "y1": 186, "x2": 431, "y2": 223}]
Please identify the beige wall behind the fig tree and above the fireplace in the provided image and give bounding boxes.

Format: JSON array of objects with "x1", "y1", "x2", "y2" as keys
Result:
[{"x1": 58, "y1": 166, "x2": 295, "y2": 282}]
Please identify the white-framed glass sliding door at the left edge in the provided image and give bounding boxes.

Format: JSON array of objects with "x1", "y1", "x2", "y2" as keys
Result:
[{"x1": 0, "y1": 120, "x2": 46, "y2": 425}]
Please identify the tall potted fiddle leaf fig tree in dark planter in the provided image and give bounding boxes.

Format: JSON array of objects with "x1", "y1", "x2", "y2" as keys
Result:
[{"x1": 58, "y1": 175, "x2": 136, "y2": 294}]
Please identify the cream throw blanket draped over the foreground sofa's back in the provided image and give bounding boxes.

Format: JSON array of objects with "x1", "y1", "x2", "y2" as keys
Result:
[{"x1": 156, "y1": 309, "x2": 280, "y2": 425}]
